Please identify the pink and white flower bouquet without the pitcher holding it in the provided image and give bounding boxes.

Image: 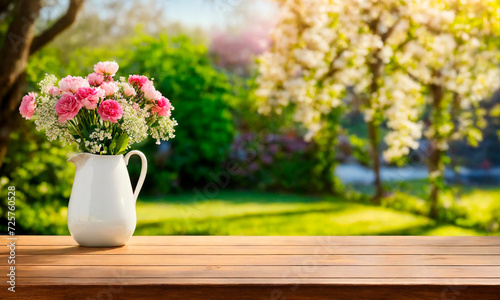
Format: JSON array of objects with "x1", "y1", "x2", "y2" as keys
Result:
[{"x1": 19, "y1": 61, "x2": 177, "y2": 155}]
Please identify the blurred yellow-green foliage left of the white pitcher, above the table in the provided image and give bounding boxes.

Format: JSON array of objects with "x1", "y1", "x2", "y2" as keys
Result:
[{"x1": 0, "y1": 122, "x2": 76, "y2": 234}]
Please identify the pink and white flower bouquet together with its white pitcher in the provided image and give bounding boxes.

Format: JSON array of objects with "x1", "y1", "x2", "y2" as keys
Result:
[{"x1": 19, "y1": 62, "x2": 177, "y2": 247}]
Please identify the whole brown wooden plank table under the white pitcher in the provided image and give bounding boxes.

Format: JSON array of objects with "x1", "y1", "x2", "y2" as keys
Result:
[{"x1": 0, "y1": 236, "x2": 500, "y2": 300}]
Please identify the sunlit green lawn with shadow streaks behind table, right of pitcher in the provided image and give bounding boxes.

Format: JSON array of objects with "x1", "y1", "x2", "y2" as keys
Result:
[{"x1": 135, "y1": 190, "x2": 500, "y2": 235}]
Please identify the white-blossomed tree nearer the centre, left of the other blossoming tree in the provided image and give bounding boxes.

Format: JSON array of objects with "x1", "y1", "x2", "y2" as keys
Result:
[{"x1": 257, "y1": 0, "x2": 421, "y2": 201}]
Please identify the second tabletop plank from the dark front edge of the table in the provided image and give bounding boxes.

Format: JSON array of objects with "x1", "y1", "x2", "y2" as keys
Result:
[{"x1": 0, "y1": 254, "x2": 500, "y2": 266}]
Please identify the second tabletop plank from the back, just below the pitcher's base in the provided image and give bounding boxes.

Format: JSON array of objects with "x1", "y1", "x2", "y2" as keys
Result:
[{"x1": 0, "y1": 245, "x2": 500, "y2": 255}]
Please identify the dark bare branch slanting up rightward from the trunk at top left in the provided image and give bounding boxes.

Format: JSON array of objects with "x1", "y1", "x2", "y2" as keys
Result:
[{"x1": 30, "y1": 0, "x2": 85, "y2": 55}]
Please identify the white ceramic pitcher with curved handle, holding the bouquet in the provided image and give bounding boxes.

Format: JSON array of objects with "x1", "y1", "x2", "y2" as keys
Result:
[{"x1": 68, "y1": 150, "x2": 147, "y2": 247}]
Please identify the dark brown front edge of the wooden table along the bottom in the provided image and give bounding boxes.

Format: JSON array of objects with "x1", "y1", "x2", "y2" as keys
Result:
[{"x1": 0, "y1": 285, "x2": 500, "y2": 300}]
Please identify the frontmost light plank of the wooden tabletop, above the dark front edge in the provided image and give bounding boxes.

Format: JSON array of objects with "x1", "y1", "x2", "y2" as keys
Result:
[{"x1": 11, "y1": 262, "x2": 500, "y2": 279}]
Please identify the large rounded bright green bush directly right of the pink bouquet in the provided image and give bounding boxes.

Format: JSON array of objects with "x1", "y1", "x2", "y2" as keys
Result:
[{"x1": 123, "y1": 36, "x2": 235, "y2": 192}]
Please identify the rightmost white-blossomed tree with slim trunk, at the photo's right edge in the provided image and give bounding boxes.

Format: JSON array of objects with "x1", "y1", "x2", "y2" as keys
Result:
[{"x1": 396, "y1": 0, "x2": 500, "y2": 218}]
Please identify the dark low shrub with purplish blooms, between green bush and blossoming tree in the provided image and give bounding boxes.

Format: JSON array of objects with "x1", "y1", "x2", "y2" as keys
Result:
[{"x1": 229, "y1": 133, "x2": 331, "y2": 193}]
